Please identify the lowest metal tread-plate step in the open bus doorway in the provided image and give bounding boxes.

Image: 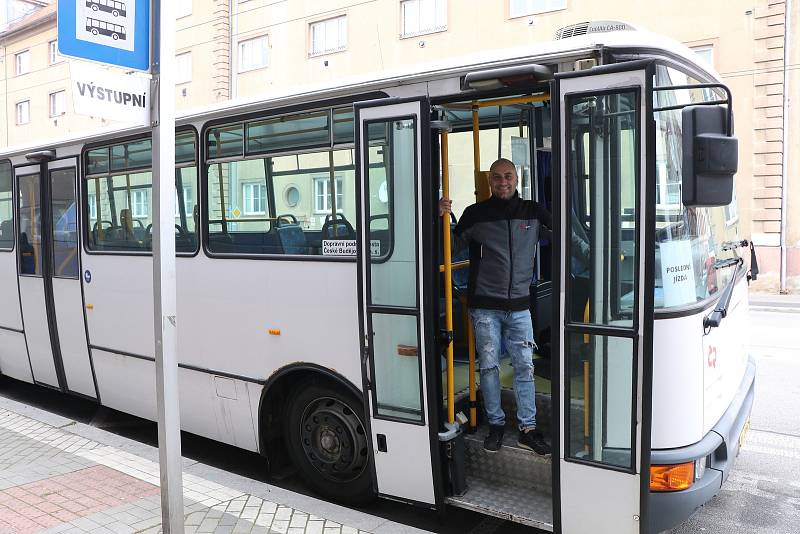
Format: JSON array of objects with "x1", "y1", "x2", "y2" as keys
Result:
[{"x1": 447, "y1": 477, "x2": 553, "y2": 532}]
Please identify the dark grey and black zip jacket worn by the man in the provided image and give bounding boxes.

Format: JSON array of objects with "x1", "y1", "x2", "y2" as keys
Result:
[{"x1": 453, "y1": 192, "x2": 552, "y2": 311}]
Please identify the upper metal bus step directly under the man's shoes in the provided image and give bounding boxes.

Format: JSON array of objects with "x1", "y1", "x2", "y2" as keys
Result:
[{"x1": 464, "y1": 425, "x2": 553, "y2": 494}]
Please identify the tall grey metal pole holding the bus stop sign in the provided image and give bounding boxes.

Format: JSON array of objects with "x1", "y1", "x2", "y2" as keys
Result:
[{"x1": 150, "y1": 0, "x2": 183, "y2": 534}]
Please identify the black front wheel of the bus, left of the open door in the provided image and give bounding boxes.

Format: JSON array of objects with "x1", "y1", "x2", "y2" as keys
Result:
[{"x1": 284, "y1": 382, "x2": 374, "y2": 503}]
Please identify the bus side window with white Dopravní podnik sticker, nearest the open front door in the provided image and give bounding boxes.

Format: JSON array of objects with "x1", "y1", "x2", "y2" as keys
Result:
[{"x1": 206, "y1": 110, "x2": 356, "y2": 258}]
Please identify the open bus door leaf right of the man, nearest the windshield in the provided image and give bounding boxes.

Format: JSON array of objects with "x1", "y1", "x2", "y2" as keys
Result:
[{"x1": 553, "y1": 61, "x2": 655, "y2": 534}]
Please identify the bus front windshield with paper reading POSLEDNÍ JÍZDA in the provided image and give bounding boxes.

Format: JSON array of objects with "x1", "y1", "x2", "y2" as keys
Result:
[{"x1": 653, "y1": 65, "x2": 739, "y2": 309}]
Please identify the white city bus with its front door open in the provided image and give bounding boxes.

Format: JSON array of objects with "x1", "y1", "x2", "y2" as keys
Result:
[{"x1": 0, "y1": 22, "x2": 757, "y2": 534}]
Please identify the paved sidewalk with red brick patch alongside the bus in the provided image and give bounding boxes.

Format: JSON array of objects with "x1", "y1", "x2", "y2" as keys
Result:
[{"x1": 0, "y1": 397, "x2": 432, "y2": 534}]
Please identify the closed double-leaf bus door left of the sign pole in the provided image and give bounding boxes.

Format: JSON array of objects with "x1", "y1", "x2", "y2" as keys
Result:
[{"x1": 15, "y1": 158, "x2": 97, "y2": 398}]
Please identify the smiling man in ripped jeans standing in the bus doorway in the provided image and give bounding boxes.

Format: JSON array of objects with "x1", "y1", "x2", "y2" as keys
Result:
[{"x1": 439, "y1": 159, "x2": 551, "y2": 455}]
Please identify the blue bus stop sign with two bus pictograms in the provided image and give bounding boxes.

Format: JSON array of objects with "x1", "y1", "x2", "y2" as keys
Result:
[{"x1": 58, "y1": 0, "x2": 150, "y2": 71}]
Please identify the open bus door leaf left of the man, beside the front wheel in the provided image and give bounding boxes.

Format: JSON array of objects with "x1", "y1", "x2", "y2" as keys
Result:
[{"x1": 354, "y1": 99, "x2": 438, "y2": 506}]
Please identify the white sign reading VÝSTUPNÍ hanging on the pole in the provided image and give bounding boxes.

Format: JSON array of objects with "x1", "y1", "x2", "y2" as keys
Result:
[{"x1": 70, "y1": 63, "x2": 150, "y2": 125}]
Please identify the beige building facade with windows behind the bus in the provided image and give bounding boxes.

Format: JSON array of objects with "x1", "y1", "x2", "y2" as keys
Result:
[{"x1": 0, "y1": 0, "x2": 800, "y2": 291}]
